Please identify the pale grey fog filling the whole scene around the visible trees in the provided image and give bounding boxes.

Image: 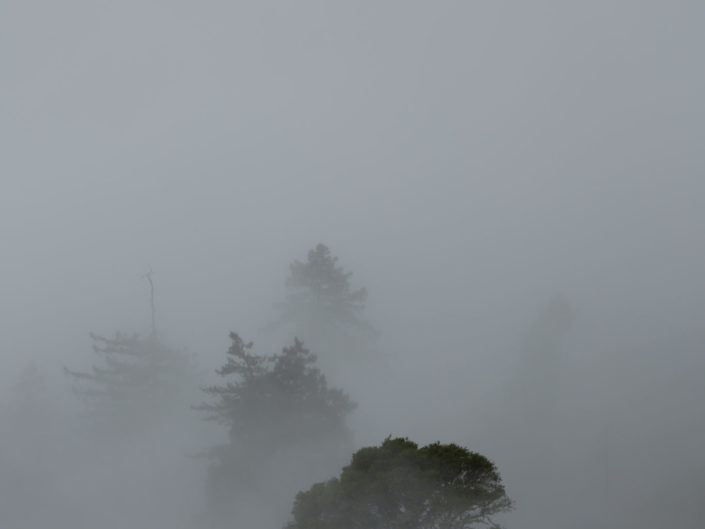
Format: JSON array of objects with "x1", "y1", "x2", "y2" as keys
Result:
[{"x1": 0, "y1": 0, "x2": 705, "y2": 529}]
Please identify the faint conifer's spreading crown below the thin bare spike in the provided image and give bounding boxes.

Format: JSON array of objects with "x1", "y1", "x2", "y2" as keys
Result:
[{"x1": 64, "y1": 332, "x2": 195, "y2": 430}]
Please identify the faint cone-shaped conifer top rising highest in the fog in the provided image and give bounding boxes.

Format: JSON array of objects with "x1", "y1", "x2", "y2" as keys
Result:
[{"x1": 269, "y1": 244, "x2": 377, "y2": 368}]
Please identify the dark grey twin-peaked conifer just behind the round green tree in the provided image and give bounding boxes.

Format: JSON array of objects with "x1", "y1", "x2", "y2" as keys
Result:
[{"x1": 197, "y1": 333, "x2": 355, "y2": 512}]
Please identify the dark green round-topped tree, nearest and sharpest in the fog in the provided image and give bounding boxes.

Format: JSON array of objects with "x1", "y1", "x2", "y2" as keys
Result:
[{"x1": 287, "y1": 438, "x2": 512, "y2": 529}]
